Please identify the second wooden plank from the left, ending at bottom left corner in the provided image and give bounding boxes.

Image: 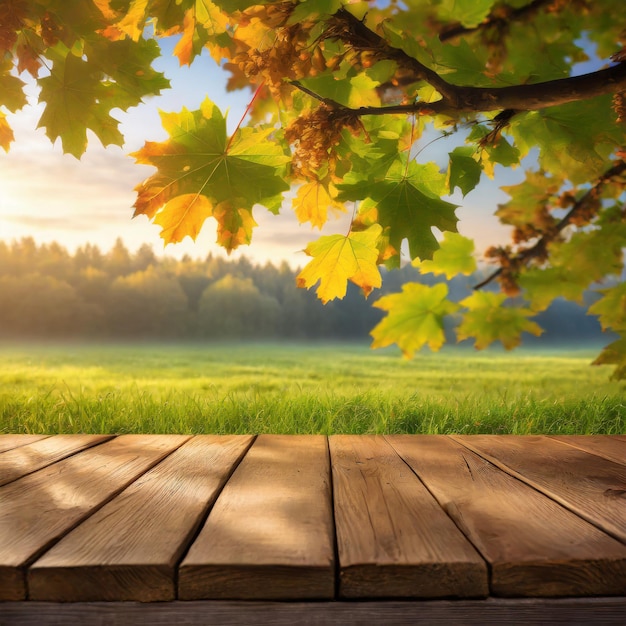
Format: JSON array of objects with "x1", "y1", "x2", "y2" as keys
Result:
[{"x1": 0, "y1": 435, "x2": 189, "y2": 600}]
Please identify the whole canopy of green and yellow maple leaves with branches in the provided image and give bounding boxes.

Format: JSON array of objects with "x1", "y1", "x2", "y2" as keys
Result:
[{"x1": 0, "y1": 0, "x2": 626, "y2": 377}]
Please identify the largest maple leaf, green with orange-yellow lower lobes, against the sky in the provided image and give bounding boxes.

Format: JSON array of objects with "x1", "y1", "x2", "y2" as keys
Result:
[{"x1": 132, "y1": 98, "x2": 289, "y2": 250}]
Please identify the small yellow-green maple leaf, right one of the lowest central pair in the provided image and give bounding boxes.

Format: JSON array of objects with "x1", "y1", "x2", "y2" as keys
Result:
[{"x1": 456, "y1": 291, "x2": 543, "y2": 350}]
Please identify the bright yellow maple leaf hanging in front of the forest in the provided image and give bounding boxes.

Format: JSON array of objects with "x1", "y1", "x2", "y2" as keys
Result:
[{"x1": 296, "y1": 224, "x2": 382, "y2": 304}]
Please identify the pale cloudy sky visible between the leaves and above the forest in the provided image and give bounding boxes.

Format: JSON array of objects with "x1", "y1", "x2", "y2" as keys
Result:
[{"x1": 0, "y1": 36, "x2": 521, "y2": 267}]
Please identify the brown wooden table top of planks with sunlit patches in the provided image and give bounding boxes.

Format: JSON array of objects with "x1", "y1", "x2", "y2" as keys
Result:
[{"x1": 0, "y1": 435, "x2": 626, "y2": 602}]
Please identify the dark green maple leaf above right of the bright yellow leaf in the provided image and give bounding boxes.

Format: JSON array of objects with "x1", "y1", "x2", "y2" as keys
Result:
[{"x1": 338, "y1": 155, "x2": 457, "y2": 259}]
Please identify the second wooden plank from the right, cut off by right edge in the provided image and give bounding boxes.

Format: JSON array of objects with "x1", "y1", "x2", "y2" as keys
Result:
[{"x1": 453, "y1": 435, "x2": 626, "y2": 543}]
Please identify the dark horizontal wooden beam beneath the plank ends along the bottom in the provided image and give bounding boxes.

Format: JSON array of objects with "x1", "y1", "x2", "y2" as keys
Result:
[{"x1": 0, "y1": 598, "x2": 626, "y2": 626}]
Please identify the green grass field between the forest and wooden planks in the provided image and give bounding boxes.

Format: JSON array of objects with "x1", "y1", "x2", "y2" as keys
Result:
[{"x1": 0, "y1": 344, "x2": 626, "y2": 434}]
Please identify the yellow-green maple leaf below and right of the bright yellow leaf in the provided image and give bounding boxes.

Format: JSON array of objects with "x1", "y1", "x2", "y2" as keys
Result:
[{"x1": 370, "y1": 283, "x2": 458, "y2": 358}]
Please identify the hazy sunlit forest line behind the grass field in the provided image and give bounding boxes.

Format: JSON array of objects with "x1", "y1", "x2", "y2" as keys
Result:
[{"x1": 0, "y1": 238, "x2": 607, "y2": 346}]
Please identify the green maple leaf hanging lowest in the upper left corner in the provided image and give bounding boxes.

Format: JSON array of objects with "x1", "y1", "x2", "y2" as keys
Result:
[{"x1": 38, "y1": 44, "x2": 124, "y2": 158}]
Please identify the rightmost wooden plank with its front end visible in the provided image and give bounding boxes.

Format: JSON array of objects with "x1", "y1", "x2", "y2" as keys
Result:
[{"x1": 387, "y1": 435, "x2": 626, "y2": 597}]
